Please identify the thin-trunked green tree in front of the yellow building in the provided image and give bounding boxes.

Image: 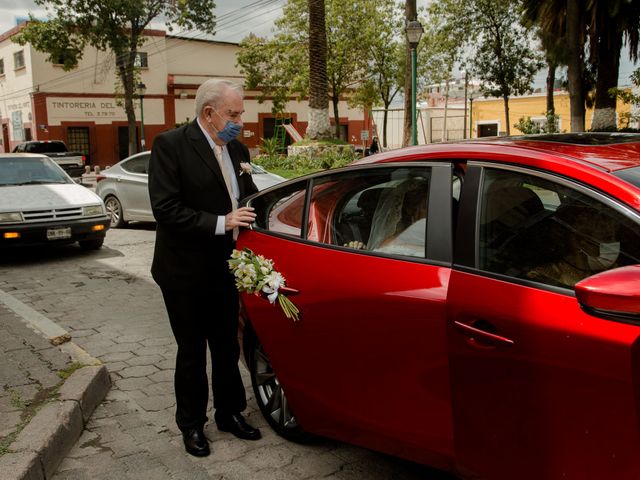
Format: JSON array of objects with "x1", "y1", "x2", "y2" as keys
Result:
[{"x1": 467, "y1": 0, "x2": 542, "y2": 135}]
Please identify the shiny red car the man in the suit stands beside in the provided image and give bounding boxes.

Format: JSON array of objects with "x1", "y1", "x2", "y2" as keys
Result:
[{"x1": 238, "y1": 134, "x2": 640, "y2": 480}]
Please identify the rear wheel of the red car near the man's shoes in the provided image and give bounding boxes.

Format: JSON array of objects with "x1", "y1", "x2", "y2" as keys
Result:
[{"x1": 249, "y1": 336, "x2": 312, "y2": 442}]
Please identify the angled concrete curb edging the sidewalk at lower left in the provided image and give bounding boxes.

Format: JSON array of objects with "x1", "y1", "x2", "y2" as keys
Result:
[{"x1": 0, "y1": 290, "x2": 111, "y2": 480}]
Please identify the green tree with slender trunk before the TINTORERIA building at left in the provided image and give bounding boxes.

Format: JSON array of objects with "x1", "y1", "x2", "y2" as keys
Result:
[{"x1": 13, "y1": 0, "x2": 215, "y2": 154}]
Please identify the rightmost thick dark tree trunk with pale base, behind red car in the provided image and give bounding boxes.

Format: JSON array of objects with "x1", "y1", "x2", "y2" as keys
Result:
[{"x1": 591, "y1": 31, "x2": 622, "y2": 132}]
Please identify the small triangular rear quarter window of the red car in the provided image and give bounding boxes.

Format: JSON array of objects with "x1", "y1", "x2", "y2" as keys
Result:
[{"x1": 250, "y1": 181, "x2": 307, "y2": 237}]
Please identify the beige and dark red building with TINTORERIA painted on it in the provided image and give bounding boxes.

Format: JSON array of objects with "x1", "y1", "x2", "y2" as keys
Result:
[{"x1": 0, "y1": 24, "x2": 370, "y2": 166}]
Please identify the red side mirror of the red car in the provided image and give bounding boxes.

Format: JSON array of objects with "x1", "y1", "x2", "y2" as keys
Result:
[{"x1": 575, "y1": 265, "x2": 640, "y2": 323}]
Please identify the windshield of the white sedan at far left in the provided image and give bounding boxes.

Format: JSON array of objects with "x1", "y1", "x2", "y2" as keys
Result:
[{"x1": 0, "y1": 157, "x2": 73, "y2": 187}]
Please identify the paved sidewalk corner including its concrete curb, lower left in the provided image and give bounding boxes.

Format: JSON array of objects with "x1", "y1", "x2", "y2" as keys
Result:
[{"x1": 0, "y1": 290, "x2": 110, "y2": 480}]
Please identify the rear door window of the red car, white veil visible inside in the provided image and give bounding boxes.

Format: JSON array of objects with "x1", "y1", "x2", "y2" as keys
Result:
[{"x1": 307, "y1": 167, "x2": 430, "y2": 257}]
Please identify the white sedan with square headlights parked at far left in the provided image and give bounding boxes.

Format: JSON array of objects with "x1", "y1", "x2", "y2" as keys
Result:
[{"x1": 0, "y1": 153, "x2": 109, "y2": 249}]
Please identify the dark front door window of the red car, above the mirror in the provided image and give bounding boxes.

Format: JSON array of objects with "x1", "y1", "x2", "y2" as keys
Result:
[{"x1": 478, "y1": 169, "x2": 640, "y2": 288}]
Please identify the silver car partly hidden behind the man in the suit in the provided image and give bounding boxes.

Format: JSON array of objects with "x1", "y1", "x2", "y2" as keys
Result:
[{"x1": 96, "y1": 152, "x2": 284, "y2": 228}]
